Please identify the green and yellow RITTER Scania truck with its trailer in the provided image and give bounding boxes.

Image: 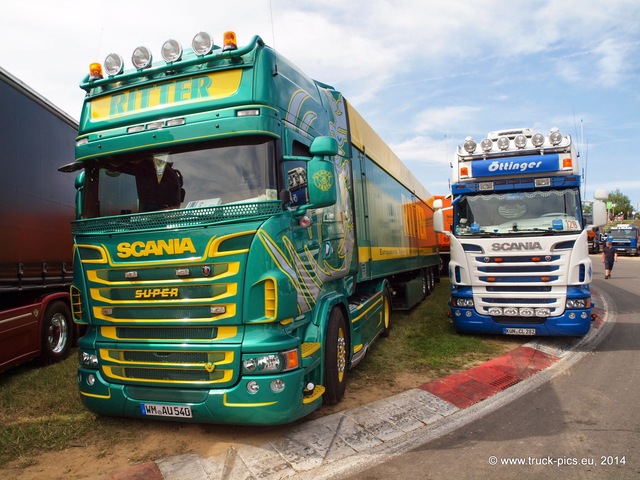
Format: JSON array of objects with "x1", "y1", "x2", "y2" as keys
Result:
[{"x1": 60, "y1": 32, "x2": 439, "y2": 424}]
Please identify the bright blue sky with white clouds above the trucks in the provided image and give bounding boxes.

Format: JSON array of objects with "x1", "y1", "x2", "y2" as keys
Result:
[{"x1": 0, "y1": 0, "x2": 640, "y2": 209}]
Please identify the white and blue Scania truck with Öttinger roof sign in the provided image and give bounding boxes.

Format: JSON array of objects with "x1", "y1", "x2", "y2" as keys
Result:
[{"x1": 434, "y1": 129, "x2": 606, "y2": 336}]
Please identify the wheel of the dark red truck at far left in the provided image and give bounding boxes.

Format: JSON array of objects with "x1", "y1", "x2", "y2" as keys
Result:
[{"x1": 40, "y1": 302, "x2": 73, "y2": 364}]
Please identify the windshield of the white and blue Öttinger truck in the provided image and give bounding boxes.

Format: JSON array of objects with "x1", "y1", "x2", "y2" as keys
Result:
[{"x1": 454, "y1": 189, "x2": 582, "y2": 235}]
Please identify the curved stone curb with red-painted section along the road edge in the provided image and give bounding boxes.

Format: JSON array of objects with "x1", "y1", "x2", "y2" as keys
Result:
[{"x1": 110, "y1": 291, "x2": 607, "y2": 480}]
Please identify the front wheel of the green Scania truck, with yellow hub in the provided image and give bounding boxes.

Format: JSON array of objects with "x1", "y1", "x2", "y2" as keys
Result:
[{"x1": 322, "y1": 308, "x2": 349, "y2": 405}]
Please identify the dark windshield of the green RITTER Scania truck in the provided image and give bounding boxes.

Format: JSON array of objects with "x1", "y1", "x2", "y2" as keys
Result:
[{"x1": 83, "y1": 137, "x2": 278, "y2": 218}]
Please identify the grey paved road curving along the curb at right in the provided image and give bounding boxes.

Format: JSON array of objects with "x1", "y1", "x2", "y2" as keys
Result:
[{"x1": 342, "y1": 255, "x2": 640, "y2": 480}]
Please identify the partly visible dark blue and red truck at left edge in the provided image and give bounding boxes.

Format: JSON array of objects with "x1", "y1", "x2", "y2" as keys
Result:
[{"x1": 0, "y1": 68, "x2": 77, "y2": 371}]
